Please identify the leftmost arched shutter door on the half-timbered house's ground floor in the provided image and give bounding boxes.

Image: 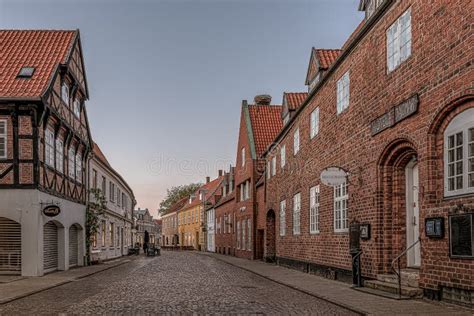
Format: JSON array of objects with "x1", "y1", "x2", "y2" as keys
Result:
[{"x1": 0, "y1": 217, "x2": 21, "y2": 274}]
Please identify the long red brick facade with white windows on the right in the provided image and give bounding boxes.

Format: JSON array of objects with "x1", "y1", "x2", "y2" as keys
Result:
[{"x1": 259, "y1": 0, "x2": 474, "y2": 300}]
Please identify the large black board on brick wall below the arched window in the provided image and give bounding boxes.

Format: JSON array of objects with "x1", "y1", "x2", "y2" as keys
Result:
[{"x1": 449, "y1": 213, "x2": 474, "y2": 258}]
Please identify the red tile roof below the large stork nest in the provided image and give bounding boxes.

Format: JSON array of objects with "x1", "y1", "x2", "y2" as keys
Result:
[{"x1": 249, "y1": 105, "x2": 283, "y2": 158}]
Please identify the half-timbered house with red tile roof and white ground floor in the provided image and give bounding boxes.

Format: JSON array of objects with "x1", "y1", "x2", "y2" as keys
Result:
[{"x1": 0, "y1": 30, "x2": 91, "y2": 276}]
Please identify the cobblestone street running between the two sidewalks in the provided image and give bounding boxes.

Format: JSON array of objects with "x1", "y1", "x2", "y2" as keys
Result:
[{"x1": 0, "y1": 252, "x2": 354, "y2": 315}]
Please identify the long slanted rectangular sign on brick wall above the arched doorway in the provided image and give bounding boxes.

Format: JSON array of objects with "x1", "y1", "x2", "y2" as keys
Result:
[{"x1": 370, "y1": 94, "x2": 419, "y2": 136}]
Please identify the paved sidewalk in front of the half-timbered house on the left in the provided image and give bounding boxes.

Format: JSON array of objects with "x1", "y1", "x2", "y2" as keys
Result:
[{"x1": 0, "y1": 257, "x2": 132, "y2": 305}]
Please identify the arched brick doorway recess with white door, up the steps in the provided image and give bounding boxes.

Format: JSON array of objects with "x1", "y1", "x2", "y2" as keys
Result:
[{"x1": 378, "y1": 139, "x2": 421, "y2": 272}]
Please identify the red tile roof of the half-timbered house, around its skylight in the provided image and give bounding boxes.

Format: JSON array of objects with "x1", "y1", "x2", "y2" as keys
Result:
[{"x1": 0, "y1": 30, "x2": 78, "y2": 98}]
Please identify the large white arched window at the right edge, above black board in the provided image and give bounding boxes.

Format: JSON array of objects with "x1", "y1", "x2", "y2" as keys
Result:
[{"x1": 444, "y1": 109, "x2": 474, "y2": 196}]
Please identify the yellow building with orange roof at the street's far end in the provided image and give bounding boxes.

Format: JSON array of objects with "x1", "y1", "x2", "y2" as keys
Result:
[{"x1": 178, "y1": 176, "x2": 222, "y2": 250}]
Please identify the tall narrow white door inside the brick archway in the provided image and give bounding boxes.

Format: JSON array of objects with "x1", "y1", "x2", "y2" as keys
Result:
[{"x1": 406, "y1": 162, "x2": 421, "y2": 268}]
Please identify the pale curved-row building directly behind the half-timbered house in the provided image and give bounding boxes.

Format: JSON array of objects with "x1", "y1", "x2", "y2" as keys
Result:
[{"x1": 88, "y1": 143, "x2": 136, "y2": 261}]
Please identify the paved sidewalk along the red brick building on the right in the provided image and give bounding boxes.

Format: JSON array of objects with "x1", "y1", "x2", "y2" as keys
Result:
[{"x1": 201, "y1": 252, "x2": 474, "y2": 316}]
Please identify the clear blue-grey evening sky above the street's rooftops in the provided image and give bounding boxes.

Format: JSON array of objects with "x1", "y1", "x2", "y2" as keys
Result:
[{"x1": 0, "y1": 0, "x2": 363, "y2": 215}]
